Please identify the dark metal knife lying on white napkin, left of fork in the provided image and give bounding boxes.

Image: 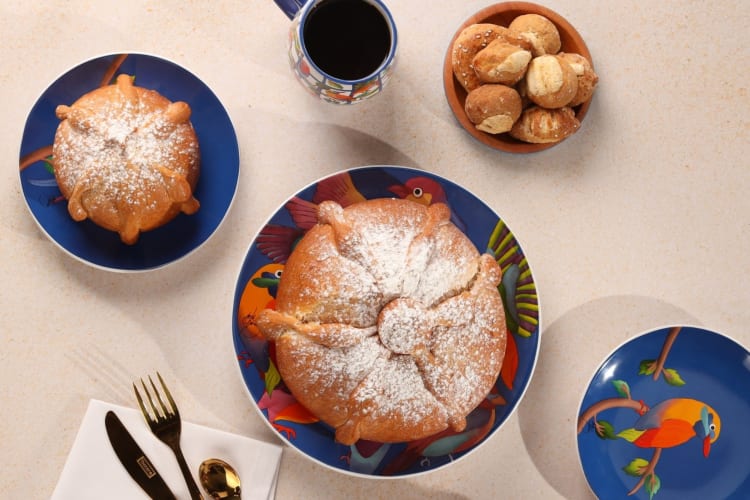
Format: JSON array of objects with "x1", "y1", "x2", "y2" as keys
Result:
[{"x1": 104, "y1": 410, "x2": 177, "y2": 500}]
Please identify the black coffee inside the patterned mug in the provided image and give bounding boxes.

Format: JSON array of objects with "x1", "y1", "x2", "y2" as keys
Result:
[{"x1": 302, "y1": 0, "x2": 391, "y2": 80}]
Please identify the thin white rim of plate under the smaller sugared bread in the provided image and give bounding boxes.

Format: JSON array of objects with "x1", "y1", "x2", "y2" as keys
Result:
[{"x1": 16, "y1": 50, "x2": 242, "y2": 274}]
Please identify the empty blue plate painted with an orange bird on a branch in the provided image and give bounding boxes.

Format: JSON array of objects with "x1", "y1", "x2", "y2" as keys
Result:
[{"x1": 577, "y1": 326, "x2": 750, "y2": 500}]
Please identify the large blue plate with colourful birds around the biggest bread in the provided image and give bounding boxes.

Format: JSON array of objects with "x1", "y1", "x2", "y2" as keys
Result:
[{"x1": 232, "y1": 166, "x2": 540, "y2": 477}]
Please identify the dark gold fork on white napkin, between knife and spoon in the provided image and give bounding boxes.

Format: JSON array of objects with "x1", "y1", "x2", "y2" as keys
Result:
[{"x1": 133, "y1": 372, "x2": 203, "y2": 500}]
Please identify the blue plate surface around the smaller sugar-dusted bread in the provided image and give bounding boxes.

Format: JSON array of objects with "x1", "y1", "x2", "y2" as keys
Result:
[{"x1": 19, "y1": 54, "x2": 239, "y2": 271}]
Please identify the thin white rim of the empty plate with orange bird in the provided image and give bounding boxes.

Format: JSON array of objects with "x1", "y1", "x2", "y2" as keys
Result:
[{"x1": 571, "y1": 323, "x2": 750, "y2": 498}]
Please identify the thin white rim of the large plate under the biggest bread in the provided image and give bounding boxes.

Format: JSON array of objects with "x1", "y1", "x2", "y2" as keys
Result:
[{"x1": 230, "y1": 164, "x2": 543, "y2": 480}]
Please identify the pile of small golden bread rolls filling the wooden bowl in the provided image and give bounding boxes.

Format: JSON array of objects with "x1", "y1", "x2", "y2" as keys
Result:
[{"x1": 451, "y1": 14, "x2": 599, "y2": 144}]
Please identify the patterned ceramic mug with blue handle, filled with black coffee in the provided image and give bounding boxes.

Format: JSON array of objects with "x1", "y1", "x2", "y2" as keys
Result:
[{"x1": 274, "y1": 0, "x2": 396, "y2": 104}]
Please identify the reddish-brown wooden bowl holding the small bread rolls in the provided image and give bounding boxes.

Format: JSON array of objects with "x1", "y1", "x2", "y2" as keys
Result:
[{"x1": 443, "y1": 2, "x2": 593, "y2": 153}]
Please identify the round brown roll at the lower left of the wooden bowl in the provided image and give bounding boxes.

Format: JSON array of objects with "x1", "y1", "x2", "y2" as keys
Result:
[{"x1": 464, "y1": 83, "x2": 523, "y2": 134}]
